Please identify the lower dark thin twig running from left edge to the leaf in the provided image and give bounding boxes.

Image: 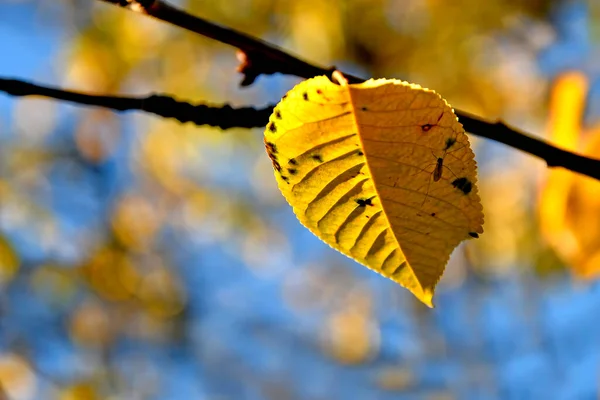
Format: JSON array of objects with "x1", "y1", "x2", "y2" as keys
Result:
[{"x1": 0, "y1": 78, "x2": 273, "y2": 129}]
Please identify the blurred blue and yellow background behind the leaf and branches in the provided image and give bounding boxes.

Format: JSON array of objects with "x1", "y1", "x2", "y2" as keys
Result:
[{"x1": 0, "y1": 0, "x2": 600, "y2": 400}]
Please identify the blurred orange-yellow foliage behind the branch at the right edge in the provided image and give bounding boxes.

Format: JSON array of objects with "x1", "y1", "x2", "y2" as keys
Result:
[{"x1": 539, "y1": 72, "x2": 600, "y2": 278}]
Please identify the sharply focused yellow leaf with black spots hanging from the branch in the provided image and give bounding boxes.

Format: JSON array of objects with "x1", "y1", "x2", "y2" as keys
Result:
[{"x1": 265, "y1": 76, "x2": 483, "y2": 307}]
